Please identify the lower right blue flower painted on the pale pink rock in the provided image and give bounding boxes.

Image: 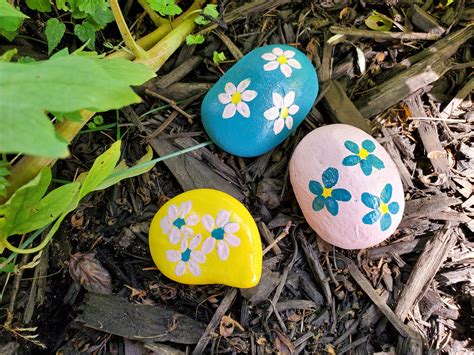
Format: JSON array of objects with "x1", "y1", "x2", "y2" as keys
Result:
[{"x1": 362, "y1": 184, "x2": 400, "y2": 232}]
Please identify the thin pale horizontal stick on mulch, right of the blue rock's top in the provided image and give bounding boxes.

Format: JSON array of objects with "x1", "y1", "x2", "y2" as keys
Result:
[{"x1": 329, "y1": 26, "x2": 440, "y2": 41}]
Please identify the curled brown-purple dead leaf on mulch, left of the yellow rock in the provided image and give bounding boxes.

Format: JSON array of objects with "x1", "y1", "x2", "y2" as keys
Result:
[{"x1": 69, "y1": 253, "x2": 112, "y2": 295}]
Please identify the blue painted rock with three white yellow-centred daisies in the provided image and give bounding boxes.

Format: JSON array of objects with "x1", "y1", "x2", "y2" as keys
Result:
[{"x1": 201, "y1": 44, "x2": 318, "y2": 157}]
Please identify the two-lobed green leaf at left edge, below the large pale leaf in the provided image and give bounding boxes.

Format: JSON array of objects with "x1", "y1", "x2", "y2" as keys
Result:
[{"x1": 0, "y1": 168, "x2": 80, "y2": 239}]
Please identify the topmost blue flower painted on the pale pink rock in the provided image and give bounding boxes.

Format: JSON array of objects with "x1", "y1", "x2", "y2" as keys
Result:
[{"x1": 342, "y1": 139, "x2": 385, "y2": 176}]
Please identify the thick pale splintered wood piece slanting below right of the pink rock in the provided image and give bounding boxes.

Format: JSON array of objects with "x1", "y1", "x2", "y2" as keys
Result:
[{"x1": 395, "y1": 222, "x2": 457, "y2": 320}]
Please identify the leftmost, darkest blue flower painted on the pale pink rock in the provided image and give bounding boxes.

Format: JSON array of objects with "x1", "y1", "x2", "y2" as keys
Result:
[{"x1": 309, "y1": 168, "x2": 352, "y2": 216}]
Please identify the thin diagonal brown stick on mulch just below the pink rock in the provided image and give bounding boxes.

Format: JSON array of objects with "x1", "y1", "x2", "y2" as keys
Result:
[{"x1": 338, "y1": 255, "x2": 419, "y2": 338}]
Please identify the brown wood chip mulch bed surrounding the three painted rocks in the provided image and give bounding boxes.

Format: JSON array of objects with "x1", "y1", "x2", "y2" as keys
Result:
[{"x1": 0, "y1": 0, "x2": 474, "y2": 354}]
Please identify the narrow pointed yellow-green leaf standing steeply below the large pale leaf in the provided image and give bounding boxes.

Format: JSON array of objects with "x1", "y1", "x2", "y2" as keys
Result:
[{"x1": 79, "y1": 141, "x2": 121, "y2": 199}]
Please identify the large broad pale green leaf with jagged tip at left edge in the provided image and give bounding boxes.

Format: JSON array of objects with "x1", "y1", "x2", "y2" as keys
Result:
[{"x1": 0, "y1": 55, "x2": 155, "y2": 157}]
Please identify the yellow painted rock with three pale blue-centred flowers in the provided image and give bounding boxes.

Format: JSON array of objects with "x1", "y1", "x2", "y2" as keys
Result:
[{"x1": 149, "y1": 189, "x2": 262, "y2": 288}]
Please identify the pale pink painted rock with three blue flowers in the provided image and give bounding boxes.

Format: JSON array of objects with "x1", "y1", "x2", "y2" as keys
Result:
[{"x1": 290, "y1": 124, "x2": 405, "y2": 249}]
